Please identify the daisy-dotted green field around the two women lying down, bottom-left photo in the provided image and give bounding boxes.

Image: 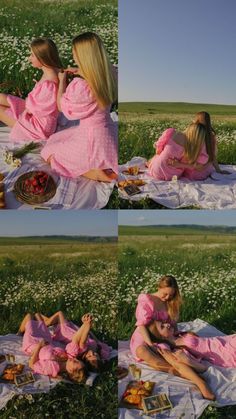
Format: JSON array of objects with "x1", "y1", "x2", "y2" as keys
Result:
[{"x1": 0, "y1": 238, "x2": 117, "y2": 419}]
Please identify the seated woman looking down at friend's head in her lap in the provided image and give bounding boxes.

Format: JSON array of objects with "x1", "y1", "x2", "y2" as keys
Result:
[{"x1": 130, "y1": 275, "x2": 215, "y2": 400}]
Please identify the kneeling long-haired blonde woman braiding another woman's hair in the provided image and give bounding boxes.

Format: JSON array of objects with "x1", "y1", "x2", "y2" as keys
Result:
[{"x1": 41, "y1": 32, "x2": 118, "y2": 182}]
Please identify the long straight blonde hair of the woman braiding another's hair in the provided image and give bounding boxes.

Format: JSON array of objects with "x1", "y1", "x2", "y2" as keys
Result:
[{"x1": 72, "y1": 32, "x2": 117, "y2": 108}]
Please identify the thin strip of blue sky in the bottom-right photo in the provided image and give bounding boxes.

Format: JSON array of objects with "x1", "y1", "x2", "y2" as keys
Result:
[{"x1": 118, "y1": 210, "x2": 236, "y2": 226}]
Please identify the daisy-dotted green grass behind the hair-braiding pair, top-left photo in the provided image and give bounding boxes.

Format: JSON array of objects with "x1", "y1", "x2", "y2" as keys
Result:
[{"x1": 0, "y1": 0, "x2": 118, "y2": 97}]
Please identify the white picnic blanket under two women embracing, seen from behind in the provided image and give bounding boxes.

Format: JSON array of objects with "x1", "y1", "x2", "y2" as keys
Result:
[{"x1": 119, "y1": 157, "x2": 236, "y2": 209}]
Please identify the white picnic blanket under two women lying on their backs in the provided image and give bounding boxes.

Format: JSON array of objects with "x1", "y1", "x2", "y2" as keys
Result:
[{"x1": 0, "y1": 334, "x2": 117, "y2": 410}]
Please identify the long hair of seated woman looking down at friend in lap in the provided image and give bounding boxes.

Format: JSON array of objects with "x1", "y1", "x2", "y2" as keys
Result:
[{"x1": 157, "y1": 275, "x2": 182, "y2": 321}]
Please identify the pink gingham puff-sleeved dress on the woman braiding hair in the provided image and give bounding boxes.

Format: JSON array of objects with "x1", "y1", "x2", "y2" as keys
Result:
[{"x1": 41, "y1": 77, "x2": 118, "y2": 178}]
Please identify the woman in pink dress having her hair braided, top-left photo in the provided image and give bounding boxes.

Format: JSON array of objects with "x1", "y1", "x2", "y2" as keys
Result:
[{"x1": 0, "y1": 38, "x2": 62, "y2": 141}]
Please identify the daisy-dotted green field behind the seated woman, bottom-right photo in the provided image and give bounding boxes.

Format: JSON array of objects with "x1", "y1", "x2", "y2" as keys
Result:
[{"x1": 118, "y1": 226, "x2": 236, "y2": 419}]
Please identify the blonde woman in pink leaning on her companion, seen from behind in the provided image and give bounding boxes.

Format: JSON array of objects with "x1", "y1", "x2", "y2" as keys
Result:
[{"x1": 148, "y1": 123, "x2": 209, "y2": 180}]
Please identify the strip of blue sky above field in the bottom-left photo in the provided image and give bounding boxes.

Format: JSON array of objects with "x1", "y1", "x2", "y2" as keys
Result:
[{"x1": 0, "y1": 210, "x2": 117, "y2": 236}]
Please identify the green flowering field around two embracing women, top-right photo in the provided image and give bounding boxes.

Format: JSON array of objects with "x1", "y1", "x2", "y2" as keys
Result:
[{"x1": 119, "y1": 102, "x2": 236, "y2": 209}]
